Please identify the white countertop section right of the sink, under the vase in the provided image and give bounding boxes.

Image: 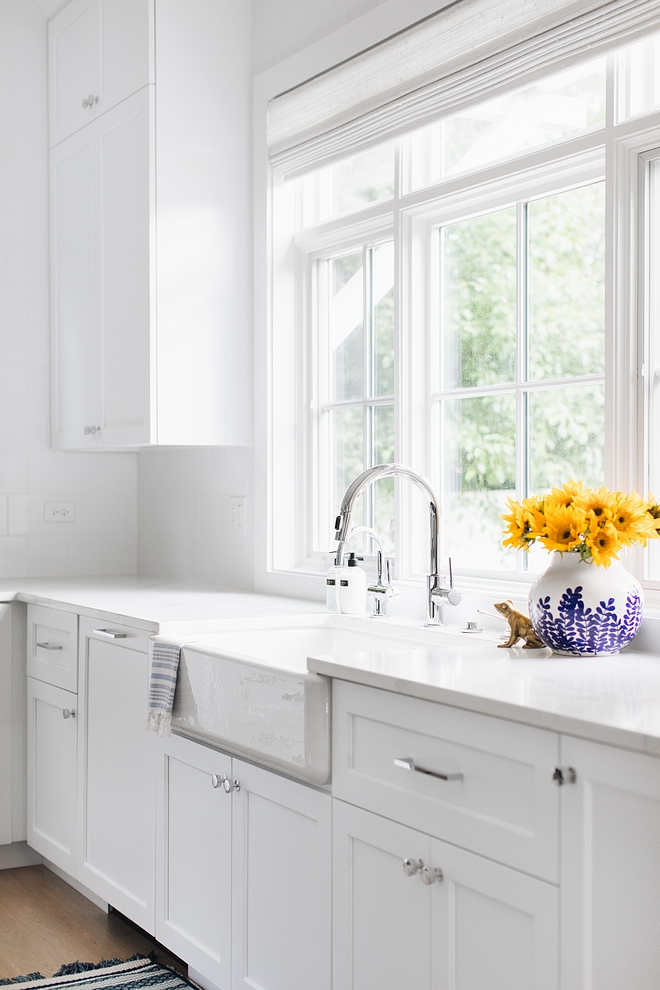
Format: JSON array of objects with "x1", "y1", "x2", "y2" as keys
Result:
[{"x1": 308, "y1": 637, "x2": 660, "y2": 756}]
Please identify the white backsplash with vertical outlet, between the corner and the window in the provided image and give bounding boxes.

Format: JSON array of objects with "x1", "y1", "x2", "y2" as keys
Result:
[{"x1": 138, "y1": 447, "x2": 254, "y2": 590}]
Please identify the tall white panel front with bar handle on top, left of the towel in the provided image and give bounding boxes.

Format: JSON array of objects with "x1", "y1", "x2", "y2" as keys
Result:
[{"x1": 77, "y1": 617, "x2": 156, "y2": 934}]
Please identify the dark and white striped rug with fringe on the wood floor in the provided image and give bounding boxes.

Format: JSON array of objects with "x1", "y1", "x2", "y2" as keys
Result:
[{"x1": 0, "y1": 956, "x2": 192, "y2": 990}]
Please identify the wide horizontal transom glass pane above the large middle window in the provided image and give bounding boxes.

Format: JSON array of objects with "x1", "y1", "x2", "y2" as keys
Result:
[{"x1": 409, "y1": 58, "x2": 605, "y2": 189}]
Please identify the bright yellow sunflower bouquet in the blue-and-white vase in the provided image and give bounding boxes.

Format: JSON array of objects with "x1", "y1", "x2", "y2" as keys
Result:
[{"x1": 502, "y1": 481, "x2": 660, "y2": 567}]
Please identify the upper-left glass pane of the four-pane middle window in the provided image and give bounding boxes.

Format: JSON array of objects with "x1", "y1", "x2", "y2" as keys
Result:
[{"x1": 442, "y1": 208, "x2": 516, "y2": 389}]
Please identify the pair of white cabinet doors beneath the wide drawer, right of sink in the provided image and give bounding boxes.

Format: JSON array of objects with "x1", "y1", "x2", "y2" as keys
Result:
[{"x1": 333, "y1": 800, "x2": 559, "y2": 990}]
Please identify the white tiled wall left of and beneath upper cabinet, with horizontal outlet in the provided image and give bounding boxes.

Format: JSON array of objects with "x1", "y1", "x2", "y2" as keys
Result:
[{"x1": 0, "y1": 0, "x2": 137, "y2": 577}]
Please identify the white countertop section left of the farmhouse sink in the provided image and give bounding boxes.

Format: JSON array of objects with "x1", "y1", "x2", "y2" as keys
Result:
[{"x1": 0, "y1": 576, "x2": 320, "y2": 635}]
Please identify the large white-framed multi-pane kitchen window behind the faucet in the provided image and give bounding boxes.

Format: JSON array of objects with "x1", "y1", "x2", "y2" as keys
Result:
[{"x1": 266, "y1": 25, "x2": 660, "y2": 604}]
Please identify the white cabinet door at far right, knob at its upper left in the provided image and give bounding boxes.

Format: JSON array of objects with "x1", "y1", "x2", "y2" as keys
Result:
[{"x1": 561, "y1": 736, "x2": 660, "y2": 990}]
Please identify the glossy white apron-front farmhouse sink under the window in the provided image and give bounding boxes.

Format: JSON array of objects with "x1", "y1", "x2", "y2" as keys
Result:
[{"x1": 173, "y1": 613, "x2": 466, "y2": 784}]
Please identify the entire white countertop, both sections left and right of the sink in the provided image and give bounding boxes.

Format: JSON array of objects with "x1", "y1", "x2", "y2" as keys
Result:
[{"x1": 0, "y1": 577, "x2": 660, "y2": 756}]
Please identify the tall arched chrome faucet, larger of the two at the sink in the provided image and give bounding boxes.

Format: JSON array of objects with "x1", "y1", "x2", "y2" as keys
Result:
[{"x1": 335, "y1": 464, "x2": 462, "y2": 626}]
